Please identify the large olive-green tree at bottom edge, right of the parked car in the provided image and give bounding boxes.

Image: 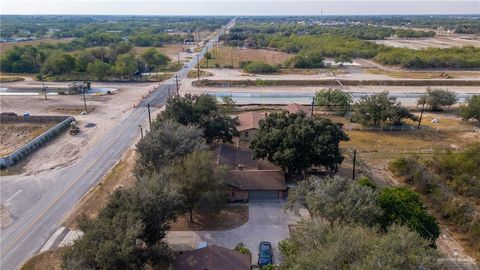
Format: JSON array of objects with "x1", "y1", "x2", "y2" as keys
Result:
[{"x1": 279, "y1": 219, "x2": 443, "y2": 270}]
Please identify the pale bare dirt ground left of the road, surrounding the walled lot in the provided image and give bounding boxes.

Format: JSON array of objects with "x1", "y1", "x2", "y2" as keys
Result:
[{"x1": 0, "y1": 81, "x2": 155, "y2": 175}]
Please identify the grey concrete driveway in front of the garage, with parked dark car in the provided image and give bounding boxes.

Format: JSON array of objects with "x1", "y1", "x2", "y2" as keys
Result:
[{"x1": 167, "y1": 201, "x2": 306, "y2": 264}]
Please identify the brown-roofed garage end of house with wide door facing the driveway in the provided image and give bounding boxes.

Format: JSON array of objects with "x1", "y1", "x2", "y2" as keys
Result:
[{"x1": 225, "y1": 170, "x2": 287, "y2": 202}]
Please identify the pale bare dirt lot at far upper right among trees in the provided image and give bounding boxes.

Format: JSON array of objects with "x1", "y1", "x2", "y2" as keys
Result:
[{"x1": 373, "y1": 35, "x2": 480, "y2": 50}]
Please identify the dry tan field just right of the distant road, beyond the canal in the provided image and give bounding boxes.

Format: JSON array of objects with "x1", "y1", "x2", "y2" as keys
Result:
[{"x1": 201, "y1": 47, "x2": 293, "y2": 68}]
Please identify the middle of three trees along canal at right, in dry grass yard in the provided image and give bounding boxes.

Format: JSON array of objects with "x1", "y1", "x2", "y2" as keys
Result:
[{"x1": 352, "y1": 91, "x2": 417, "y2": 126}]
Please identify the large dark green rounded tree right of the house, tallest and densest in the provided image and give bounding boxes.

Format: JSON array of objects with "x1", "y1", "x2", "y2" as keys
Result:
[{"x1": 250, "y1": 112, "x2": 348, "y2": 173}]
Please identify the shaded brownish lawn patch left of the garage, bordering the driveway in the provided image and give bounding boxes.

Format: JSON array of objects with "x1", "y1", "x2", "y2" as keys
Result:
[{"x1": 170, "y1": 204, "x2": 248, "y2": 231}]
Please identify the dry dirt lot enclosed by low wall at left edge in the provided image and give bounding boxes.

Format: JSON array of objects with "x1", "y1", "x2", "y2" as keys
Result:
[{"x1": 0, "y1": 122, "x2": 58, "y2": 156}]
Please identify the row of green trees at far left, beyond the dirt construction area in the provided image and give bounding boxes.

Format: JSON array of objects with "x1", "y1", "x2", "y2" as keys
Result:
[{"x1": 0, "y1": 42, "x2": 172, "y2": 80}]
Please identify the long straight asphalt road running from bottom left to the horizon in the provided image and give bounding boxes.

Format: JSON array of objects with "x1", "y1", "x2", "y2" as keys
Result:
[{"x1": 0, "y1": 17, "x2": 234, "y2": 270}]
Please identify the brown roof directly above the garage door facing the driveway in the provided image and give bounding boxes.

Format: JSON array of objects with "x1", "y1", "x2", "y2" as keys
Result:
[{"x1": 225, "y1": 170, "x2": 286, "y2": 190}]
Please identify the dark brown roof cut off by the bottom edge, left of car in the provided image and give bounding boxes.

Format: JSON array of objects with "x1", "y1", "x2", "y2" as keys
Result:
[{"x1": 173, "y1": 245, "x2": 251, "y2": 270}]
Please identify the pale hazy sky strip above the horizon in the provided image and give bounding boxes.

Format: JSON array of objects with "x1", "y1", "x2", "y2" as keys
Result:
[{"x1": 0, "y1": 0, "x2": 480, "y2": 15}]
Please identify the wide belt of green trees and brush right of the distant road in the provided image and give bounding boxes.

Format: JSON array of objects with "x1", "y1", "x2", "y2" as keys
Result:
[{"x1": 224, "y1": 26, "x2": 480, "y2": 68}]
